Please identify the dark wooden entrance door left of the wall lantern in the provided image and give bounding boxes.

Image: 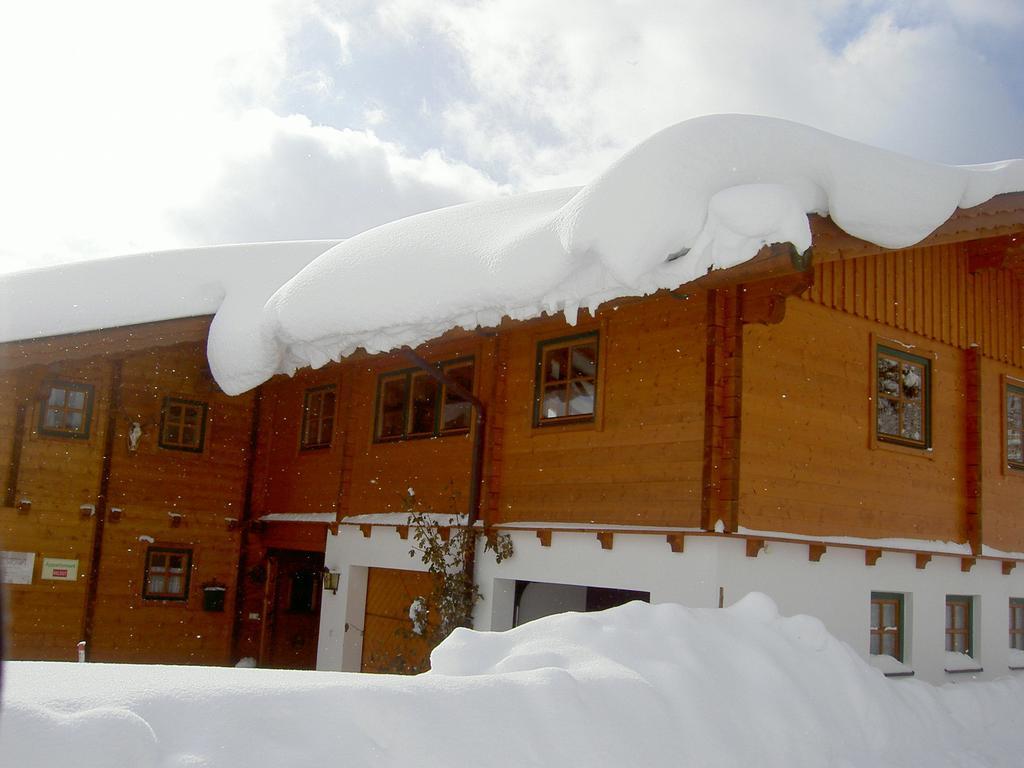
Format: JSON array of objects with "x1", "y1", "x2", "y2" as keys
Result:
[{"x1": 260, "y1": 550, "x2": 324, "y2": 670}]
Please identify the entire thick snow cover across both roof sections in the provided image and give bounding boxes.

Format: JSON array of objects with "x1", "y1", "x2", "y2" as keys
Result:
[{"x1": 0, "y1": 115, "x2": 1024, "y2": 394}]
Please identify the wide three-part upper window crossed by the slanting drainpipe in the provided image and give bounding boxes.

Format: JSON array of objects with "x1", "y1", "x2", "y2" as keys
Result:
[{"x1": 374, "y1": 359, "x2": 474, "y2": 440}]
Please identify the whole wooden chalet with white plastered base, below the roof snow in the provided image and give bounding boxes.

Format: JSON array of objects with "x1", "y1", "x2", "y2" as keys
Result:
[{"x1": 0, "y1": 120, "x2": 1024, "y2": 681}]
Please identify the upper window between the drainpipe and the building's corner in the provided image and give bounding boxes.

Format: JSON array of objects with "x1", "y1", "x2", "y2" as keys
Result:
[{"x1": 534, "y1": 333, "x2": 597, "y2": 426}]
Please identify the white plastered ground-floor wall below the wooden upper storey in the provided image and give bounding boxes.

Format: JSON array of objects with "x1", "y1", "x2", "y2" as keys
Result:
[{"x1": 317, "y1": 526, "x2": 1024, "y2": 683}]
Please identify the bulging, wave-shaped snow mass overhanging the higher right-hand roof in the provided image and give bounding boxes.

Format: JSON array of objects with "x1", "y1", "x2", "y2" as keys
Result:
[{"x1": 264, "y1": 115, "x2": 1024, "y2": 391}]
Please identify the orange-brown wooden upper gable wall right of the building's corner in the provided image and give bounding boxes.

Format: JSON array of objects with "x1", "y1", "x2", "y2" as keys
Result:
[{"x1": 740, "y1": 244, "x2": 1024, "y2": 552}]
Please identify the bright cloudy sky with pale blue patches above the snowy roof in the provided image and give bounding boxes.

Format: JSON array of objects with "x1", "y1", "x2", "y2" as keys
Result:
[{"x1": 0, "y1": 0, "x2": 1024, "y2": 271}]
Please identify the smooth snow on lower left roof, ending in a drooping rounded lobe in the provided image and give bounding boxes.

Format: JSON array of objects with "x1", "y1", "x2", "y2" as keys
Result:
[{"x1": 0, "y1": 240, "x2": 338, "y2": 392}]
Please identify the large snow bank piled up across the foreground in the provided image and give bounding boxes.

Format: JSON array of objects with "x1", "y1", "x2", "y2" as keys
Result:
[{"x1": 0, "y1": 595, "x2": 1024, "y2": 768}]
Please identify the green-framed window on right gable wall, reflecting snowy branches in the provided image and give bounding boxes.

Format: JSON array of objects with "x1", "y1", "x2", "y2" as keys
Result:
[{"x1": 874, "y1": 345, "x2": 932, "y2": 449}]
